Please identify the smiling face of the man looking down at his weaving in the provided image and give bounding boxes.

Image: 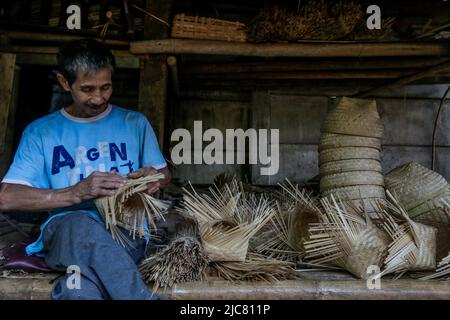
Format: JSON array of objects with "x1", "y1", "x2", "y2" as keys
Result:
[{"x1": 59, "y1": 68, "x2": 112, "y2": 117}]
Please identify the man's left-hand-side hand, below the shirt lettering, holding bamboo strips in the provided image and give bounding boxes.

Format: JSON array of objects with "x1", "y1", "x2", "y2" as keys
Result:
[{"x1": 71, "y1": 171, "x2": 126, "y2": 202}]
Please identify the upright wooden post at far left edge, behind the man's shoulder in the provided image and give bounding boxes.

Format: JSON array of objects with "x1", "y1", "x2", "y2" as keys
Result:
[{"x1": 0, "y1": 53, "x2": 17, "y2": 177}]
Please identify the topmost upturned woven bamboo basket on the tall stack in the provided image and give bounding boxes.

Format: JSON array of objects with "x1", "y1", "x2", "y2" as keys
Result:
[{"x1": 322, "y1": 97, "x2": 383, "y2": 138}]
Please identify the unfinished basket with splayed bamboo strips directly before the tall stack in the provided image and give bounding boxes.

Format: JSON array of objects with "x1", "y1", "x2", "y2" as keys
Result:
[{"x1": 305, "y1": 196, "x2": 389, "y2": 279}]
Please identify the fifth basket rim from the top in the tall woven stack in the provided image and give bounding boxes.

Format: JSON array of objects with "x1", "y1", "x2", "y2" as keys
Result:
[{"x1": 320, "y1": 171, "x2": 384, "y2": 192}]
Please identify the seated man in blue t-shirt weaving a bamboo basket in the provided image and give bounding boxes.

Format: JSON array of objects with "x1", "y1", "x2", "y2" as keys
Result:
[{"x1": 0, "y1": 40, "x2": 171, "y2": 299}]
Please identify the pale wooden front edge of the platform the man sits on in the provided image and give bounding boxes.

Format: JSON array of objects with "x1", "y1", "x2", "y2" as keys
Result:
[{"x1": 4, "y1": 273, "x2": 450, "y2": 300}]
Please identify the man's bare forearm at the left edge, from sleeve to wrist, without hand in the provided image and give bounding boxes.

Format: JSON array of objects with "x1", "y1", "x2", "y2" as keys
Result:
[{"x1": 0, "y1": 183, "x2": 81, "y2": 211}]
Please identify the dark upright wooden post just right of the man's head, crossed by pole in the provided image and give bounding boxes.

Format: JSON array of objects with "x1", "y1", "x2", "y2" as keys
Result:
[{"x1": 138, "y1": 0, "x2": 172, "y2": 149}]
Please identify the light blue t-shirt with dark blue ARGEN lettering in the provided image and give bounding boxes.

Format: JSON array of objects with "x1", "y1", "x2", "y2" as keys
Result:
[{"x1": 2, "y1": 105, "x2": 167, "y2": 255}]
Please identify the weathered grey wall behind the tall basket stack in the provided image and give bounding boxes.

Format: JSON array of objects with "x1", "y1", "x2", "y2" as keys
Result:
[{"x1": 174, "y1": 85, "x2": 450, "y2": 185}]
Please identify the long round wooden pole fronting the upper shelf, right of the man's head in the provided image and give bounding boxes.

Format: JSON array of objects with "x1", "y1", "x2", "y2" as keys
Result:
[{"x1": 130, "y1": 39, "x2": 450, "y2": 58}]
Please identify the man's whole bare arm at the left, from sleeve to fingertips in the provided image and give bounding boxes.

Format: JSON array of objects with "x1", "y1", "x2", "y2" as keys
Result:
[{"x1": 0, "y1": 172, "x2": 125, "y2": 211}]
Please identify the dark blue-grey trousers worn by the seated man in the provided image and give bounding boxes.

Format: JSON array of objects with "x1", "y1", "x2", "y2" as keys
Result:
[{"x1": 43, "y1": 212, "x2": 158, "y2": 300}]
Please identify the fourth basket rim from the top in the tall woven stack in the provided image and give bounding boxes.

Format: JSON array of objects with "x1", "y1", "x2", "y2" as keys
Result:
[{"x1": 319, "y1": 159, "x2": 383, "y2": 176}]
